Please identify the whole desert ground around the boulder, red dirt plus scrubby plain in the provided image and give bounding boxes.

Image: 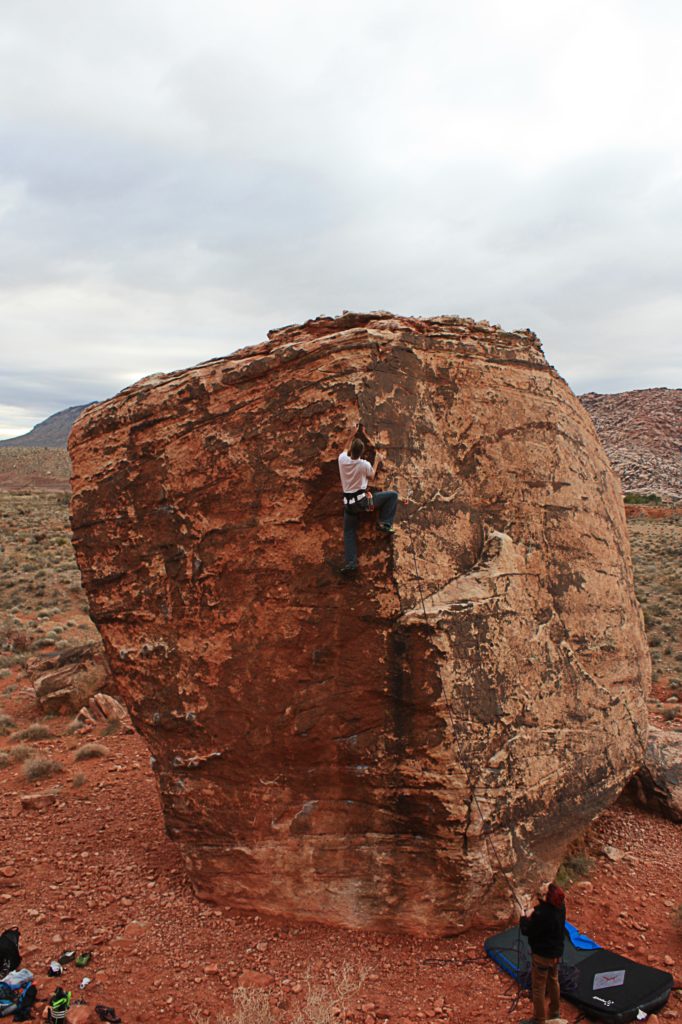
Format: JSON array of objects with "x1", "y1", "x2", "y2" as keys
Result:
[{"x1": 0, "y1": 452, "x2": 682, "y2": 1024}]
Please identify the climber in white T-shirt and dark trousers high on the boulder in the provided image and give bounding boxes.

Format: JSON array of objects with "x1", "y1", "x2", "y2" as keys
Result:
[{"x1": 339, "y1": 424, "x2": 398, "y2": 574}]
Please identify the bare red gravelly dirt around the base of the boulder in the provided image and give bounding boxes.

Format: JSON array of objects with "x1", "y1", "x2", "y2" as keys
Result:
[{"x1": 0, "y1": 671, "x2": 682, "y2": 1024}]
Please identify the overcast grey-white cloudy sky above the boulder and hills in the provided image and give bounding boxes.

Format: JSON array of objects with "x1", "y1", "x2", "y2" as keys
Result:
[{"x1": 0, "y1": 0, "x2": 682, "y2": 437}]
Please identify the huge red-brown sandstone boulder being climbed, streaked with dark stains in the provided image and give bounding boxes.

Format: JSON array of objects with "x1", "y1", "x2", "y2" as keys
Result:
[{"x1": 70, "y1": 313, "x2": 649, "y2": 935}]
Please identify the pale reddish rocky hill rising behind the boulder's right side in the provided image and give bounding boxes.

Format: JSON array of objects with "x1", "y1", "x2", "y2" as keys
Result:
[{"x1": 580, "y1": 387, "x2": 682, "y2": 502}]
